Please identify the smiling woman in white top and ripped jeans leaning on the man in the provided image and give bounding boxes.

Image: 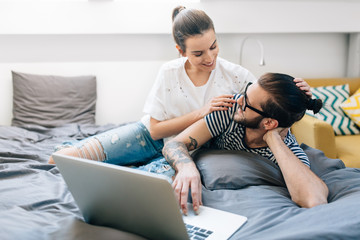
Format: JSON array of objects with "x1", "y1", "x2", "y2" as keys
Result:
[{"x1": 49, "y1": 6, "x2": 310, "y2": 180}]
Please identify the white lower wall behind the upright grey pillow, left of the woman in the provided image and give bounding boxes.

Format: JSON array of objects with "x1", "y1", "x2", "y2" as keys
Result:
[{"x1": 0, "y1": 61, "x2": 163, "y2": 125}]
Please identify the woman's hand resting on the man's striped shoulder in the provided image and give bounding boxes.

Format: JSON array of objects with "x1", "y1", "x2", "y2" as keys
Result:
[{"x1": 199, "y1": 94, "x2": 236, "y2": 118}]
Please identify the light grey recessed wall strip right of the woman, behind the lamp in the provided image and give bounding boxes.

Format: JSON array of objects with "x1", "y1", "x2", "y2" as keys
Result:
[{"x1": 219, "y1": 33, "x2": 348, "y2": 78}]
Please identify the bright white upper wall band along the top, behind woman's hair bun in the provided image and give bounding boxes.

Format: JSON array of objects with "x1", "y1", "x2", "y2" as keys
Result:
[{"x1": 0, "y1": 0, "x2": 360, "y2": 34}]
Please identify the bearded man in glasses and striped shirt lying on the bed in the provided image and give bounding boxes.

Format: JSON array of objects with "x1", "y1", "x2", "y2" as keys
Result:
[{"x1": 163, "y1": 73, "x2": 328, "y2": 214}]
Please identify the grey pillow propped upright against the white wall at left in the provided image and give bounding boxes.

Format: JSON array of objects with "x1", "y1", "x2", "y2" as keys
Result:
[{"x1": 12, "y1": 72, "x2": 96, "y2": 127}]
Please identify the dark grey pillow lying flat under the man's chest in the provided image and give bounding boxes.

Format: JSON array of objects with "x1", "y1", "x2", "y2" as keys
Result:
[{"x1": 193, "y1": 149, "x2": 285, "y2": 190}]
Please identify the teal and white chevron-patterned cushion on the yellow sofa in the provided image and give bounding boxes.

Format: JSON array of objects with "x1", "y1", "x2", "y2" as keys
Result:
[{"x1": 306, "y1": 84, "x2": 360, "y2": 135}]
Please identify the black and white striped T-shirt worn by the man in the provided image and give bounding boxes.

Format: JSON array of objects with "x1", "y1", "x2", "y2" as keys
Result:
[{"x1": 205, "y1": 94, "x2": 310, "y2": 167}]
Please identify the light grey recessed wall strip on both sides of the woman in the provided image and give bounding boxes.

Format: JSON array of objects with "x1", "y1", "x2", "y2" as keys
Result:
[{"x1": 0, "y1": 33, "x2": 348, "y2": 78}]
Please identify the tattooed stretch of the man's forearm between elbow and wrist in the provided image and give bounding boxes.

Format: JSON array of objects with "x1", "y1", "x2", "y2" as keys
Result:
[{"x1": 162, "y1": 141, "x2": 192, "y2": 169}]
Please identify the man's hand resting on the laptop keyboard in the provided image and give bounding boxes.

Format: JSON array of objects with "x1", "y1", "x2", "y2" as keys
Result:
[{"x1": 172, "y1": 162, "x2": 202, "y2": 215}]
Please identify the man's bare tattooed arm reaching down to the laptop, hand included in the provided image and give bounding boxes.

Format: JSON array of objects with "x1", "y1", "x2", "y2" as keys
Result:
[{"x1": 163, "y1": 119, "x2": 211, "y2": 215}]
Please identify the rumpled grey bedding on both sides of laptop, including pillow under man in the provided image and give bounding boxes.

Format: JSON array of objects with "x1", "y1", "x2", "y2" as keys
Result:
[{"x1": 0, "y1": 124, "x2": 360, "y2": 240}]
